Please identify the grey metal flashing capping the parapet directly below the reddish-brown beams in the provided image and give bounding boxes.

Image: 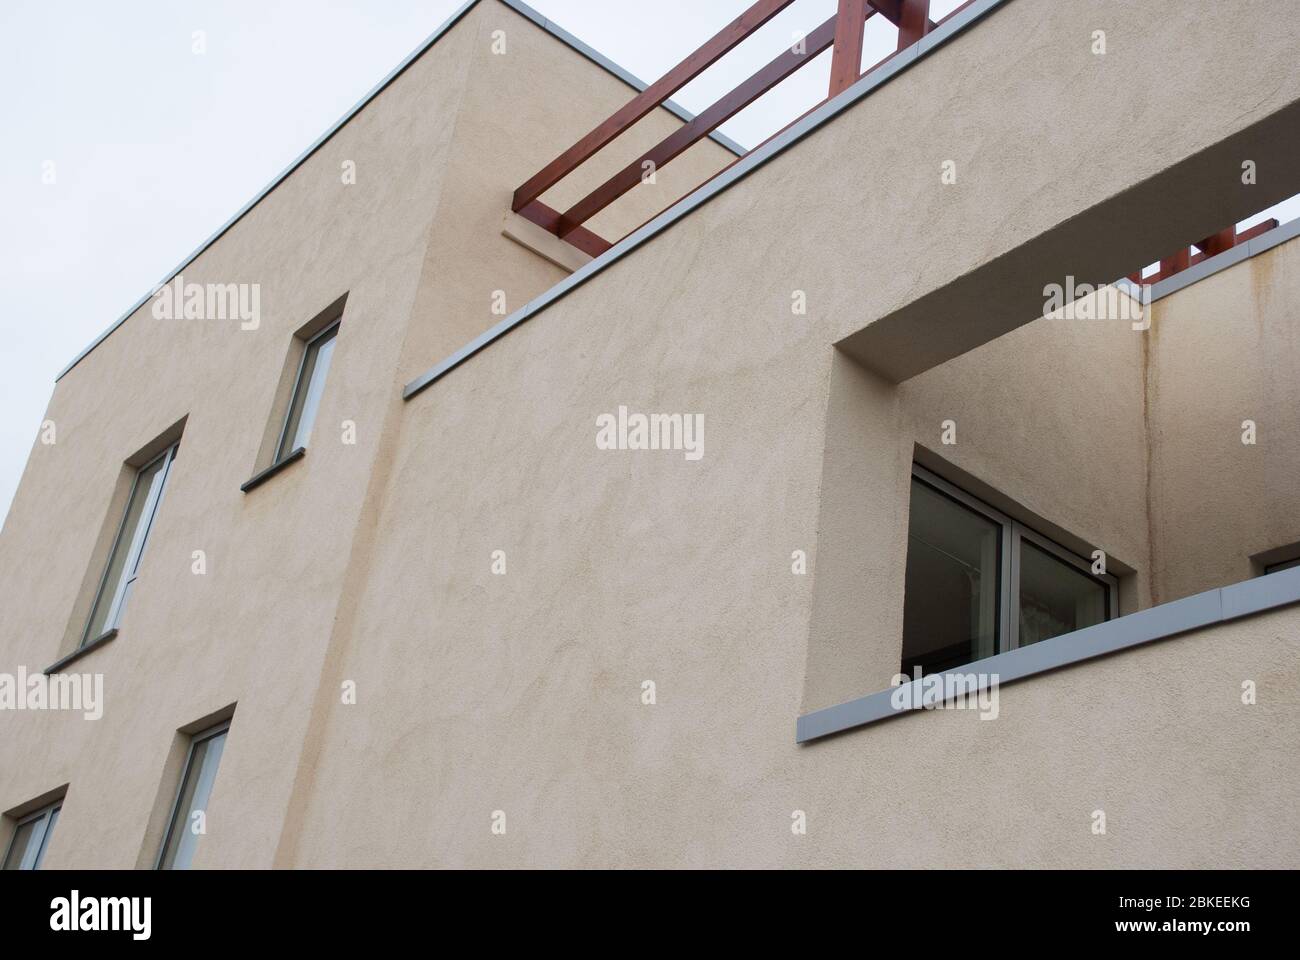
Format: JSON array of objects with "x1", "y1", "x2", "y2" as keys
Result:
[{"x1": 402, "y1": 0, "x2": 1011, "y2": 399}]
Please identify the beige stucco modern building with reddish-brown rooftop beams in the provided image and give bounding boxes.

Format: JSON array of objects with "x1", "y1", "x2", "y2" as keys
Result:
[{"x1": 0, "y1": 0, "x2": 1300, "y2": 868}]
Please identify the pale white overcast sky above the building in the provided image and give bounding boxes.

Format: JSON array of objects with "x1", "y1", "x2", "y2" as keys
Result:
[{"x1": 0, "y1": 0, "x2": 1300, "y2": 515}]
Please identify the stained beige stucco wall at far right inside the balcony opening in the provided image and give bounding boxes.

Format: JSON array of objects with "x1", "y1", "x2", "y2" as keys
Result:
[{"x1": 1147, "y1": 241, "x2": 1300, "y2": 601}]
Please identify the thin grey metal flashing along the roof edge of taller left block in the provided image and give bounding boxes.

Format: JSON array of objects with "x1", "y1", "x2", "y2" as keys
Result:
[{"x1": 55, "y1": 0, "x2": 745, "y2": 382}]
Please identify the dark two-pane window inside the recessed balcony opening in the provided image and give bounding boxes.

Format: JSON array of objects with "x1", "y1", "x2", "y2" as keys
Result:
[{"x1": 902, "y1": 466, "x2": 1119, "y2": 676}]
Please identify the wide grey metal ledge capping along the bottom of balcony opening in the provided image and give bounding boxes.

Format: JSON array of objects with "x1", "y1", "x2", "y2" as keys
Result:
[{"x1": 794, "y1": 567, "x2": 1300, "y2": 743}]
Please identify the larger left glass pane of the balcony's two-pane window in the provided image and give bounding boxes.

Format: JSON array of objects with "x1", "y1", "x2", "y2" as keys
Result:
[{"x1": 902, "y1": 480, "x2": 1002, "y2": 676}]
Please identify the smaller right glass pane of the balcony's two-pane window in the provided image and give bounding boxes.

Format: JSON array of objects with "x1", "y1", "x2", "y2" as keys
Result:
[{"x1": 1019, "y1": 539, "x2": 1106, "y2": 647}]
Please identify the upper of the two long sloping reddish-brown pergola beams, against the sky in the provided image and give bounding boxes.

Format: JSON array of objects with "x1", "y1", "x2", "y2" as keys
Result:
[{"x1": 511, "y1": 0, "x2": 794, "y2": 213}]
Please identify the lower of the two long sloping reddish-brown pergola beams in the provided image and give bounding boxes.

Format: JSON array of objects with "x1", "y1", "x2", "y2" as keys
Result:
[{"x1": 559, "y1": 10, "x2": 852, "y2": 238}]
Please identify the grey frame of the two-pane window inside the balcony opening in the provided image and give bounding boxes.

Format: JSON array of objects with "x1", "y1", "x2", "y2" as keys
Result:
[{"x1": 907, "y1": 463, "x2": 1119, "y2": 654}]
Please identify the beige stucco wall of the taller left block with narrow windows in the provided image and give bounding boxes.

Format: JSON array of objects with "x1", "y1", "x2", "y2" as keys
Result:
[{"x1": 0, "y1": 3, "x2": 731, "y2": 868}]
